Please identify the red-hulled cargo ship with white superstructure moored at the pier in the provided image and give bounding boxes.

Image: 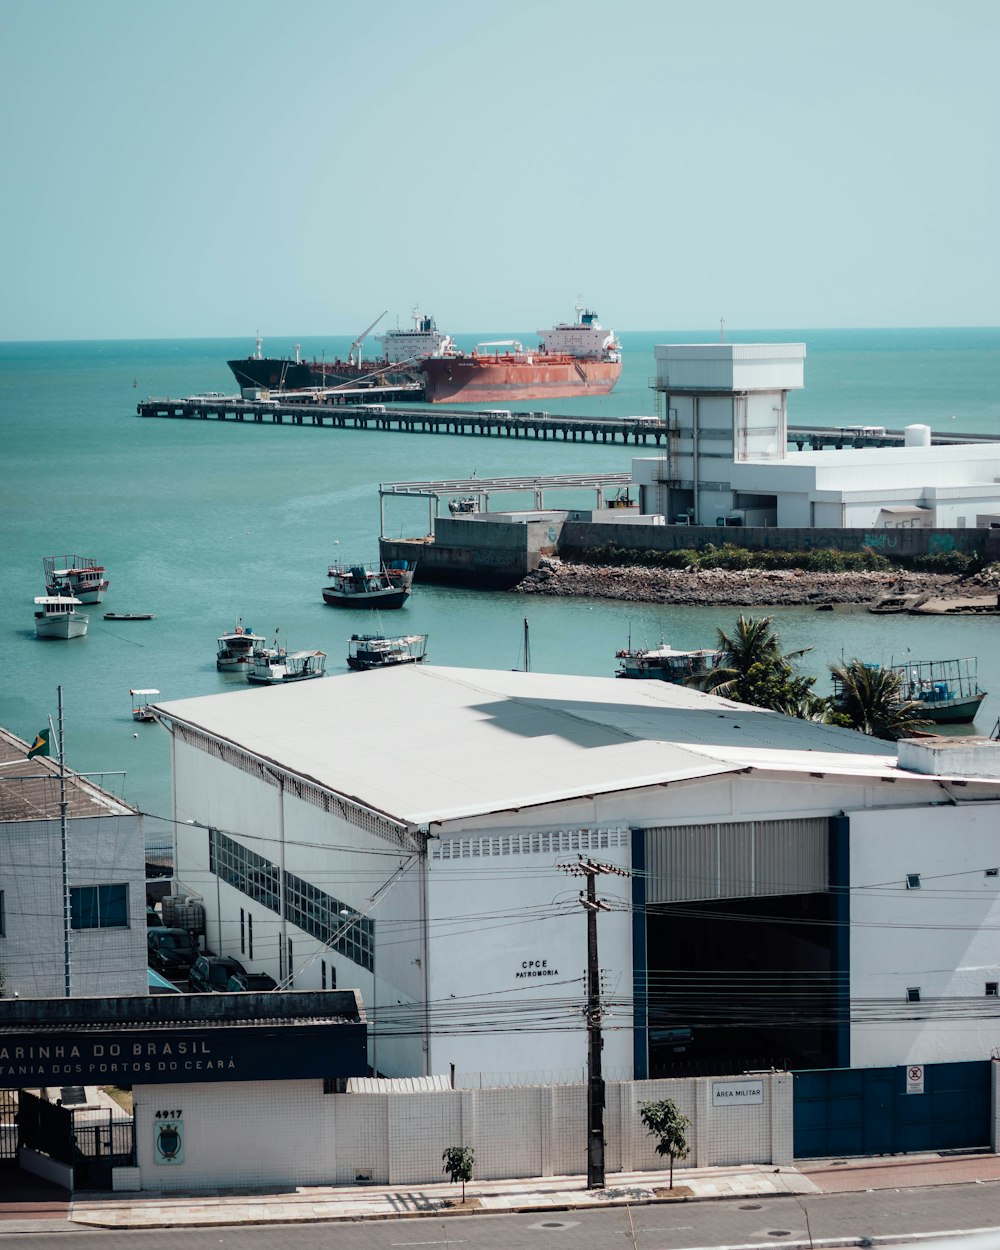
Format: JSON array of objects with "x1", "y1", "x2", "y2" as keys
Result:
[{"x1": 420, "y1": 304, "x2": 621, "y2": 404}]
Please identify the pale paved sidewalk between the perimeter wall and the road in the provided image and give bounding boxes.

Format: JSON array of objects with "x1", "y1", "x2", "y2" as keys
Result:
[{"x1": 0, "y1": 1154, "x2": 1000, "y2": 1234}]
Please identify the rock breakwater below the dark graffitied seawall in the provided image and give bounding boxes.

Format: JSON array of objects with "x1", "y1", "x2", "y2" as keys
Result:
[{"x1": 515, "y1": 558, "x2": 961, "y2": 608}]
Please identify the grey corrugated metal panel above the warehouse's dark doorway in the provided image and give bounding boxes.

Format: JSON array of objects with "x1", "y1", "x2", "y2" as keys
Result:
[{"x1": 646, "y1": 818, "x2": 829, "y2": 905}]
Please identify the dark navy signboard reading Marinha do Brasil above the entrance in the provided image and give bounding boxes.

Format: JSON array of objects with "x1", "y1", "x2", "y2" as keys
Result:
[{"x1": 0, "y1": 1021, "x2": 368, "y2": 1089}]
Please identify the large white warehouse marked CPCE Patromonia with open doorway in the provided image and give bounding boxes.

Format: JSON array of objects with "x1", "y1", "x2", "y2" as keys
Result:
[{"x1": 159, "y1": 665, "x2": 1000, "y2": 1085}]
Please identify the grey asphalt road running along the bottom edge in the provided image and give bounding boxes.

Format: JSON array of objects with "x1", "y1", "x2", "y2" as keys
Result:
[{"x1": 0, "y1": 1183, "x2": 1000, "y2": 1250}]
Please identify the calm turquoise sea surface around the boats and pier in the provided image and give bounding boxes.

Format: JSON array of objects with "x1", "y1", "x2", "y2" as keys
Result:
[{"x1": 0, "y1": 329, "x2": 1000, "y2": 845}]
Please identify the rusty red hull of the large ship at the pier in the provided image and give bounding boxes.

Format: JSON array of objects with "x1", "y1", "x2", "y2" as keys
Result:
[{"x1": 420, "y1": 355, "x2": 621, "y2": 404}]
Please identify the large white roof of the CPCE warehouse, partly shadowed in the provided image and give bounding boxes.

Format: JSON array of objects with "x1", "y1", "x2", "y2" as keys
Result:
[{"x1": 158, "y1": 665, "x2": 896, "y2": 825}]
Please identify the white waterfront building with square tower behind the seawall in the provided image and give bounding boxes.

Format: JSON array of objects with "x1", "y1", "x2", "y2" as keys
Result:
[{"x1": 633, "y1": 343, "x2": 1000, "y2": 529}]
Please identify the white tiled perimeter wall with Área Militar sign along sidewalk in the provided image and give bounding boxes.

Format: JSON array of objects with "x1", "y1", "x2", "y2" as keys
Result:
[{"x1": 128, "y1": 1073, "x2": 793, "y2": 1190}]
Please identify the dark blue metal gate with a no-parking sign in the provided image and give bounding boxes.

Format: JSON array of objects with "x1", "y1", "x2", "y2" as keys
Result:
[{"x1": 793, "y1": 1060, "x2": 993, "y2": 1159}]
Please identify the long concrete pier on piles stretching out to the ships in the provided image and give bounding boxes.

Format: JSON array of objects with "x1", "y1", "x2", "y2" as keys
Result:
[{"x1": 135, "y1": 391, "x2": 1000, "y2": 451}]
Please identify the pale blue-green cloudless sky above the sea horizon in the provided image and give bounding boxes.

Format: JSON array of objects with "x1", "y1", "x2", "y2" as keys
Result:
[{"x1": 0, "y1": 0, "x2": 1000, "y2": 341}]
